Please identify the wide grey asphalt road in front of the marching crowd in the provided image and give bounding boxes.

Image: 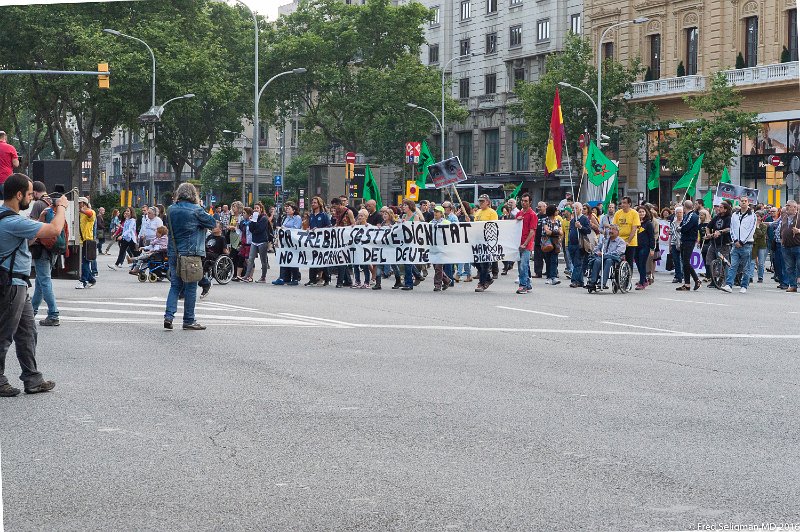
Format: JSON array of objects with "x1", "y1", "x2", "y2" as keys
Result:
[{"x1": 0, "y1": 251, "x2": 800, "y2": 531}]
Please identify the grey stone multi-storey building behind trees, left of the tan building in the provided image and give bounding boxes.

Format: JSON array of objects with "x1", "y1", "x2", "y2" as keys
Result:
[{"x1": 421, "y1": 0, "x2": 583, "y2": 199}]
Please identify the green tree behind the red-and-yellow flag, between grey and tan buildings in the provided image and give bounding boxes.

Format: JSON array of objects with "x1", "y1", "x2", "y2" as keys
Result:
[{"x1": 511, "y1": 34, "x2": 655, "y2": 166}]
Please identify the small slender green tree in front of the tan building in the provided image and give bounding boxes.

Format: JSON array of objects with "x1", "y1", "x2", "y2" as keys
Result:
[{"x1": 669, "y1": 72, "x2": 758, "y2": 185}]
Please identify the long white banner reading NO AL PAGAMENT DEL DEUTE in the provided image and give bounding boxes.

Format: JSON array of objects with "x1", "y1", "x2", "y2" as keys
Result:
[{"x1": 275, "y1": 220, "x2": 522, "y2": 268}]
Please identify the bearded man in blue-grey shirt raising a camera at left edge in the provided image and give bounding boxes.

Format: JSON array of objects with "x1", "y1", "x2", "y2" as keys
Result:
[{"x1": 0, "y1": 174, "x2": 68, "y2": 397}]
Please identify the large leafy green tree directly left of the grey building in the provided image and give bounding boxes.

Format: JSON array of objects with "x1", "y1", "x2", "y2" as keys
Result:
[{"x1": 262, "y1": 0, "x2": 467, "y2": 163}]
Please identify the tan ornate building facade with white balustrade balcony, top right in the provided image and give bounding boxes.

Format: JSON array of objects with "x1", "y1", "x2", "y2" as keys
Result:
[{"x1": 584, "y1": 0, "x2": 800, "y2": 204}]
